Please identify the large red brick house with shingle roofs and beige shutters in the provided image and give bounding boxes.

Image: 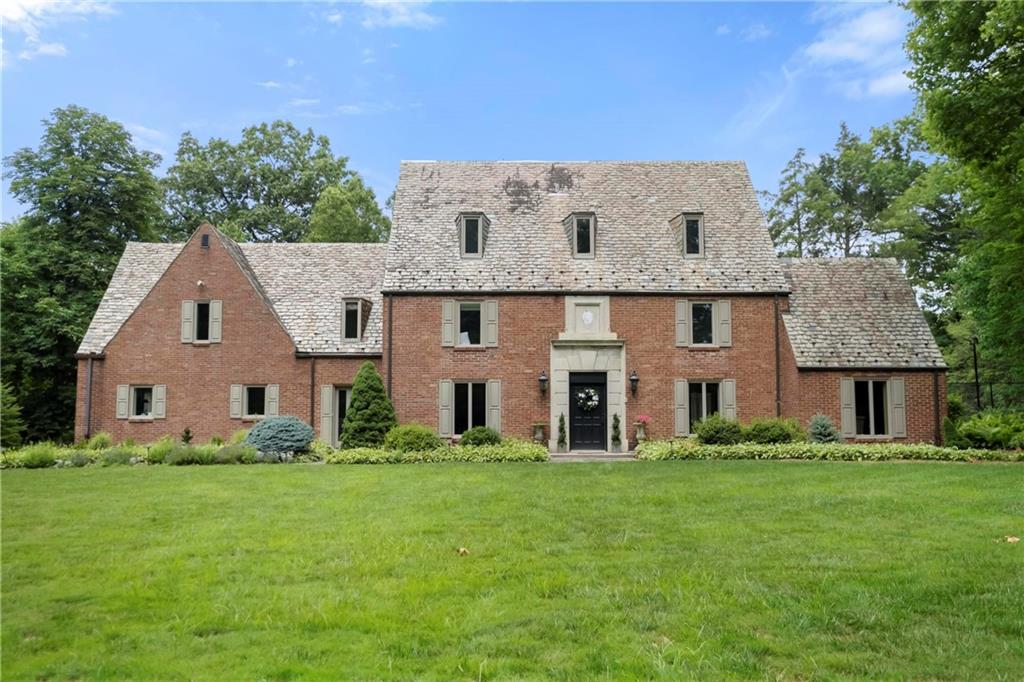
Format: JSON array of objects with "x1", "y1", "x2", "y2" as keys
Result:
[{"x1": 76, "y1": 162, "x2": 945, "y2": 450}]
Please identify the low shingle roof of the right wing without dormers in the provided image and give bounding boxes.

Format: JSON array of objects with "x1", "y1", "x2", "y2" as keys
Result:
[{"x1": 782, "y1": 258, "x2": 946, "y2": 369}]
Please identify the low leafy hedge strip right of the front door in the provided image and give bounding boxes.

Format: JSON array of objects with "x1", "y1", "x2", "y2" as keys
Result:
[{"x1": 636, "y1": 438, "x2": 1024, "y2": 462}]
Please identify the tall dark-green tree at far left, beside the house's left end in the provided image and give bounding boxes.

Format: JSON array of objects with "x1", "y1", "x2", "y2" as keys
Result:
[{"x1": 0, "y1": 106, "x2": 161, "y2": 440}]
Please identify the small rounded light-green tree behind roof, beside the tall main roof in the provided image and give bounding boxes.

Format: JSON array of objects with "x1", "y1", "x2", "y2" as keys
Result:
[{"x1": 303, "y1": 175, "x2": 391, "y2": 242}]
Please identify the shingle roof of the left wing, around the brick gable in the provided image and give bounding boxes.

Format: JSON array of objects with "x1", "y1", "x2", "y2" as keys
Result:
[{"x1": 78, "y1": 237, "x2": 386, "y2": 354}]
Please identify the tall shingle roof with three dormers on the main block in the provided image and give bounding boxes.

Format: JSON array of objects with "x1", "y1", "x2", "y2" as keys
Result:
[{"x1": 384, "y1": 161, "x2": 786, "y2": 292}]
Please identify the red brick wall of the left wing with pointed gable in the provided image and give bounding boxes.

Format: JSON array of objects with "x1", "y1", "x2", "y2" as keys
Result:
[{"x1": 75, "y1": 224, "x2": 379, "y2": 442}]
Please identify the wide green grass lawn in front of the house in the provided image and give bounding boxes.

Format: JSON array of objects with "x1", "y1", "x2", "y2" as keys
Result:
[{"x1": 2, "y1": 462, "x2": 1024, "y2": 680}]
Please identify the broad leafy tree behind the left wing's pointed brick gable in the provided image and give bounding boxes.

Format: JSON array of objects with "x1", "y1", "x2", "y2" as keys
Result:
[{"x1": 163, "y1": 121, "x2": 380, "y2": 242}]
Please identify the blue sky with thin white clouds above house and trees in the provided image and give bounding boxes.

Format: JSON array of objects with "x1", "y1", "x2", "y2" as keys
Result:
[{"x1": 0, "y1": 0, "x2": 913, "y2": 220}]
